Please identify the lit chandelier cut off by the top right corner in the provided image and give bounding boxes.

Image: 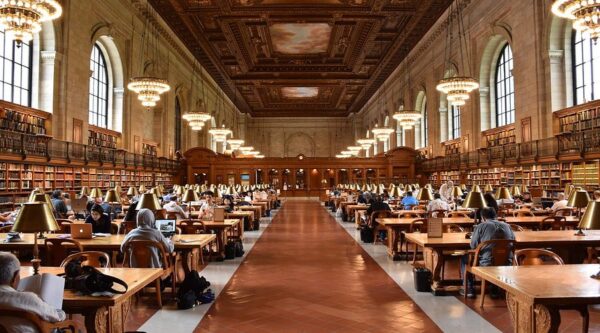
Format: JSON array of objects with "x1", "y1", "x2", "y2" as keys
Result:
[{"x1": 552, "y1": 0, "x2": 600, "y2": 39}]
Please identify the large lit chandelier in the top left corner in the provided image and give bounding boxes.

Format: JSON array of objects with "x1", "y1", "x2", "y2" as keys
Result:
[{"x1": 0, "y1": 0, "x2": 62, "y2": 45}]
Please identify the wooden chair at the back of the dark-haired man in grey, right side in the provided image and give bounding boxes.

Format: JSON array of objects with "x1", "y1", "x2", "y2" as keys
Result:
[{"x1": 463, "y1": 239, "x2": 515, "y2": 308}]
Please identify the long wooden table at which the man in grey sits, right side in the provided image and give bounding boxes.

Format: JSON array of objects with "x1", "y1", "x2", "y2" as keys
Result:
[{"x1": 405, "y1": 230, "x2": 600, "y2": 295}]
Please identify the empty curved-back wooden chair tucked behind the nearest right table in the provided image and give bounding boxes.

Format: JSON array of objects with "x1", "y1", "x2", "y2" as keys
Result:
[{"x1": 513, "y1": 249, "x2": 590, "y2": 333}]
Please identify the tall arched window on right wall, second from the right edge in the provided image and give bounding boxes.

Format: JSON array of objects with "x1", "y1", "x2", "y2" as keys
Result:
[{"x1": 496, "y1": 44, "x2": 515, "y2": 127}]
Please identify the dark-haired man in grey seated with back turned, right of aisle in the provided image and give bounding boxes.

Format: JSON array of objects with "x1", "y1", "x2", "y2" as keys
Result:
[{"x1": 460, "y1": 207, "x2": 515, "y2": 298}]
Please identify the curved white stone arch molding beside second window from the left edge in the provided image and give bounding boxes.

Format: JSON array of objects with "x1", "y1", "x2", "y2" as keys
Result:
[{"x1": 89, "y1": 23, "x2": 126, "y2": 132}]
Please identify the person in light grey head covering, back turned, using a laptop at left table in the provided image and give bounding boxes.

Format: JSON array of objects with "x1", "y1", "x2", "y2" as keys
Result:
[{"x1": 121, "y1": 208, "x2": 175, "y2": 268}]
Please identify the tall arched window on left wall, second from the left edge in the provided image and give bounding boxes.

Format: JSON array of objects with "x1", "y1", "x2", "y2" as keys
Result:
[{"x1": 89, "y1": 44, "x2": 109, "y2": 128}]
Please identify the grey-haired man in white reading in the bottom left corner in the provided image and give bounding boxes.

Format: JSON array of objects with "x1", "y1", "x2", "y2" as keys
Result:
[{"x1": 0, "y1": 252, "x2": 67, "y2": 333}]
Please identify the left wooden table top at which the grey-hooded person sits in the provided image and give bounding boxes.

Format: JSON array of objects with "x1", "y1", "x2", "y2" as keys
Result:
[{"x1": 0, "y1": 231, "x2": 216, "y2": 250}]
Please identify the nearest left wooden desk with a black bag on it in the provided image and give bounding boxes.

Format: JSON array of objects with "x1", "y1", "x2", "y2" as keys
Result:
[{"x1": 20, "y1": 266, "x2": 162, "y2": 333}]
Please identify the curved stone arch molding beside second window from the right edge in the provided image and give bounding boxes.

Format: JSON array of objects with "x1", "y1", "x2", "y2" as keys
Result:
[{"x1": 479, "y1": 24, "x2": 514, "y2": 131}]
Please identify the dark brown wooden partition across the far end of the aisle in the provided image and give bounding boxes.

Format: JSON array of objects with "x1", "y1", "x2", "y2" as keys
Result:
[{"x1": 180, "y1": 147, "x2": 417, "y2": 197}]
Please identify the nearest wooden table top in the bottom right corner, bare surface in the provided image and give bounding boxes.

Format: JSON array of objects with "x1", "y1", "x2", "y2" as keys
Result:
[{"x1": 472, "y1": 264, "x2": 600, "y2": 305}]
